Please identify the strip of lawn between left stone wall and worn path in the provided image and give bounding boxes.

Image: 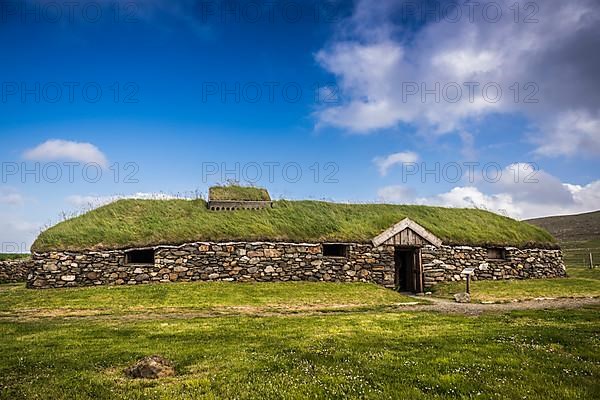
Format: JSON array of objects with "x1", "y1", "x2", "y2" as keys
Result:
[{"x1": 0, "y1": 282, "x2": 415, "y2": 315}]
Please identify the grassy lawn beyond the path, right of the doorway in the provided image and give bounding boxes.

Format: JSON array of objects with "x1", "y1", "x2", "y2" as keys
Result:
[{"x1": 434, "y1": 267, "x2": 600, "y2": 302}]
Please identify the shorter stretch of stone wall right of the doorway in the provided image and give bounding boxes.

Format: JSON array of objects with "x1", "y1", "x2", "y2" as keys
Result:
[{"x1": 421, "y1": 246, "x2": 566, "y2": 287}]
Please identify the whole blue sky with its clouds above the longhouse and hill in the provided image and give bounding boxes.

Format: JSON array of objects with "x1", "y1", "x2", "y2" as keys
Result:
[{"x1": 0, "y1": 0, "x2": 600, "y2": 251}]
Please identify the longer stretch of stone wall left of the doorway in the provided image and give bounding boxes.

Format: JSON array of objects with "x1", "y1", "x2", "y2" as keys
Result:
[{"x1": 28, "y1": 242, "x2": 394, "y2": 288}]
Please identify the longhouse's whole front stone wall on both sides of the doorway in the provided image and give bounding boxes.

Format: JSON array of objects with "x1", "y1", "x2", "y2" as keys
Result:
[{"x1": 27, "y1": 242, "x2": 565, "y2": 288}]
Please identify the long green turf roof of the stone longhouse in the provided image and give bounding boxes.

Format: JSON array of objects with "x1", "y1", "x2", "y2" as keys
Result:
[{"x1": 32, "y1": 200, "x2": 556, "y2": 252}]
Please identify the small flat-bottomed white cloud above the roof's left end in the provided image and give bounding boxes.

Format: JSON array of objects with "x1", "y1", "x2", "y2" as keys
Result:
[{"x1": 23, "y1": 139, "x2": 108, "y2": 168}]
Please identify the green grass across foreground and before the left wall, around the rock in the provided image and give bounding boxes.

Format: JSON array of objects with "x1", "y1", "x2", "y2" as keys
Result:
[{"x1": 0, "y1": 283, "x2": 600, "y2": 400}]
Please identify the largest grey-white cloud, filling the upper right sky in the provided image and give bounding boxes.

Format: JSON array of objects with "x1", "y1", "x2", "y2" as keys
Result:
[{"x1": 316, "y1": 0, "x2": 600, "y2": 156}]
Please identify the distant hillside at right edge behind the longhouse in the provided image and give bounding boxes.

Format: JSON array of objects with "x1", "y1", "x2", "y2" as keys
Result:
[{"x1": 525, "y1": 211, "x2": 600, "y2": 266}]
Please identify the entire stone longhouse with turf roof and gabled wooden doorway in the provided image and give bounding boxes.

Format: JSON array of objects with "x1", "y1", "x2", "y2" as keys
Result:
[{"x1": 28, "y1": 186, "x2": 565, "y2": 292}]
